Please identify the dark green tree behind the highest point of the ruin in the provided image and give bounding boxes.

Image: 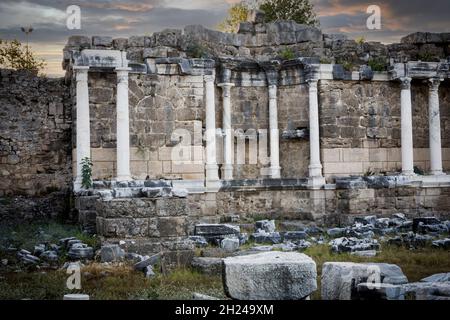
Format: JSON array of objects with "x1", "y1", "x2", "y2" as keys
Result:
[{"x1": 259, "y1": 0, "x2": 319, "y2": 26}]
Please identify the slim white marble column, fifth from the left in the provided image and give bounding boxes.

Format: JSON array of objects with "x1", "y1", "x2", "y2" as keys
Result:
[{"x1": 269, "y1": 84, "x2": 281, "y2": 179}]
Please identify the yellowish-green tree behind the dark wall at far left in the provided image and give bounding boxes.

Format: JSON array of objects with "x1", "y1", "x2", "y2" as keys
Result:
[{"x1": 0, "y1": 39, "x2": 45, "y2": 73}]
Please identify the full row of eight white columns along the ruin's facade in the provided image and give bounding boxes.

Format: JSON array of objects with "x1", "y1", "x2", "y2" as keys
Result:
[{"x1": 74, "y1": 66, "x2": 443, "y2": 188}]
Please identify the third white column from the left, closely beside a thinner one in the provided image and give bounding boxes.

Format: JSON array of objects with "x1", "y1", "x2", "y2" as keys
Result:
[{"x1": 204, "y1": 75, "x2": 219, "y2": 188}]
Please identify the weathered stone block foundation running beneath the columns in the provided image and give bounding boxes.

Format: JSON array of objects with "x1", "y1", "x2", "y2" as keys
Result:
[{"x1": 77, "y1": 177, "x2": 450, "y2": 254}]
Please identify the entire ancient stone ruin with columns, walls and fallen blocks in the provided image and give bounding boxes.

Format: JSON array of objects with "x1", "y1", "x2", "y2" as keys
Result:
[{"x1": 0, "y1": 10, "x2": 450, "y2": 299}]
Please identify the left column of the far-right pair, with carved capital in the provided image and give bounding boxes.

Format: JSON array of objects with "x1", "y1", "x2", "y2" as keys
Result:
[{"x1": 400, "y1": 77, "x2": 414, "y2": 176}]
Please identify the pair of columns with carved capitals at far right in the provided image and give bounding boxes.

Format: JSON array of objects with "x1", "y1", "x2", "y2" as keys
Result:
[{"x1": 400, "y1": 77, "x2": 444, "y2": 176}]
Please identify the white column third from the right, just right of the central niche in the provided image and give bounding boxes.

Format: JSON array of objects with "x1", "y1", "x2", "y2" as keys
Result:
[{"x1": 308, "y1": 79, "x2": 325, "y2": 189}]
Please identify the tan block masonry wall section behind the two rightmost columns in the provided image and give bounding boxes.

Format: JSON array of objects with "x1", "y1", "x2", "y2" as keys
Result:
[{"x1": 319, "y1": 80, "x2": 450, "y2": 179}]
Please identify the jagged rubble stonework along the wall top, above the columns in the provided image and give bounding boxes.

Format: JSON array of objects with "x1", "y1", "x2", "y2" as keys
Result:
[{"x1": 64, "y1": 24, "x2": 450, "y2": 71}]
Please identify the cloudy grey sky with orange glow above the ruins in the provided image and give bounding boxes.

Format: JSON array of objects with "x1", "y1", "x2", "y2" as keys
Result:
[{"x1": 0, "y1": 0, "x2": 450, "y2": 76}]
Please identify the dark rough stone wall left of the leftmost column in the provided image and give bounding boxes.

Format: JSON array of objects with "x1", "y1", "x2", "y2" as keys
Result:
[{"x1": 0, "y1": 70, "x2": 72, "y2": 197}]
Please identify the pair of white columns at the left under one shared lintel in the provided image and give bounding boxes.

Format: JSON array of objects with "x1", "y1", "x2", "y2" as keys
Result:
[{"x1": 73, "y1": 66, "x2": 131, "y2": 188}]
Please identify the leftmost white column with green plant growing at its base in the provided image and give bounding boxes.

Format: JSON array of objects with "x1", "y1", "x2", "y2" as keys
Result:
[{"x1": 73, "y1": 66, "x2": 91, "y2": 190}]
